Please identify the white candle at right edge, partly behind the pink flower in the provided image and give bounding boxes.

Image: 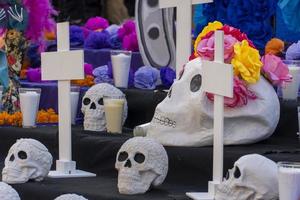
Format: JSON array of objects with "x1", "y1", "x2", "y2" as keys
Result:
[{"x1": 282, "y1": 65, "x2": 300, "y2": 100}]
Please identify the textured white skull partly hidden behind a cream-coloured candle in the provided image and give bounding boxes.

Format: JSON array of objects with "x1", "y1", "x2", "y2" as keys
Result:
[{"x1": 81, "y1": 83, "x2": 127, "y2": 131}]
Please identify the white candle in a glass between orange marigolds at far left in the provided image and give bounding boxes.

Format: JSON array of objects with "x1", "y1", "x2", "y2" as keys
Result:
[{"x1": 20, "y1": 91, "x2": 40, "y2": 128}]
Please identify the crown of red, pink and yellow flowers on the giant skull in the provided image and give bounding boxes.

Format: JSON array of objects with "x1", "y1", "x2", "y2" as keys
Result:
[{"x1": 191, "y1": 21, "x2": 291, "y2": 108}]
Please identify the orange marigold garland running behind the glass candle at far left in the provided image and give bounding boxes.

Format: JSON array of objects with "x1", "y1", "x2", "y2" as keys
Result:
[{"x1": 0, "y1": 108, "x2": 58, "y2": 126}]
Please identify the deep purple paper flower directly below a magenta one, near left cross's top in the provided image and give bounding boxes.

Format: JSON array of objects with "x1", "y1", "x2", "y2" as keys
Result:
[{"x1": 84, "y1": 31, "x2": 109, "y2": 49}]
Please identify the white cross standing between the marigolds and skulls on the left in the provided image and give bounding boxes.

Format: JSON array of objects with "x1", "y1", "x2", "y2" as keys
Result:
[{"x1": 41, "y1": 22, "x2": 95, "y2": 178}]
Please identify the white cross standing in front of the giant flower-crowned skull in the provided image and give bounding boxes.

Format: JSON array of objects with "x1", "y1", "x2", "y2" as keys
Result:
[{"x1": 187, "y1": 31, "x2": 233, "y2": 200}]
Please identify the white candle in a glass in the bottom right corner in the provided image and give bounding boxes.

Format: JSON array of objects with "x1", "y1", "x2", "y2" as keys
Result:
[{"x1": 278, "y1": 167, "x2": 300, "y2": 200}]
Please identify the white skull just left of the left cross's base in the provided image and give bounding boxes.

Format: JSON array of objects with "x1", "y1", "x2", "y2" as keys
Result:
[{"x1": 2, "y1": 139, "x2": 52, "y2": 184}]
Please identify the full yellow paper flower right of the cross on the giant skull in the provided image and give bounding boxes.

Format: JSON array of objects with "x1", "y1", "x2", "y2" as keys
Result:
[{"x1": 231, "y1": 40, "x2": 263, "y2": 84}]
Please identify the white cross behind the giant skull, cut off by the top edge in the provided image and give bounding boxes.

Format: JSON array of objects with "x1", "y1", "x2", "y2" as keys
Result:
[{"x1": 159, "y1": 0, "x2": 213, "y2": 77}]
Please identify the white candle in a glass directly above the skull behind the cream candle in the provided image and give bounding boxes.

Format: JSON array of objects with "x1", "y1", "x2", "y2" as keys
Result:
[{"x1": 111, "y1": 53, "x2": 131, "y2": 88}]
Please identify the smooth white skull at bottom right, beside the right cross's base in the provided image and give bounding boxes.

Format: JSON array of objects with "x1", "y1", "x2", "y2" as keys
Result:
[{"x1": 216, "y1": 154, "x2": 279, "y2": 200}]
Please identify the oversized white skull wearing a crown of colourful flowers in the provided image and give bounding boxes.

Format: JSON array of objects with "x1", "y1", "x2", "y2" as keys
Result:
[{"x1": 147, "y1": 58, "x2": 280, "y2": 146}]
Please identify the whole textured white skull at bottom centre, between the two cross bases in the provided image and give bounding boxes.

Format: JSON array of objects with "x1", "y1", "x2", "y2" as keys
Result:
[{"x1": 116, "y1": 137, "x2": 168, "y2": 194}]
